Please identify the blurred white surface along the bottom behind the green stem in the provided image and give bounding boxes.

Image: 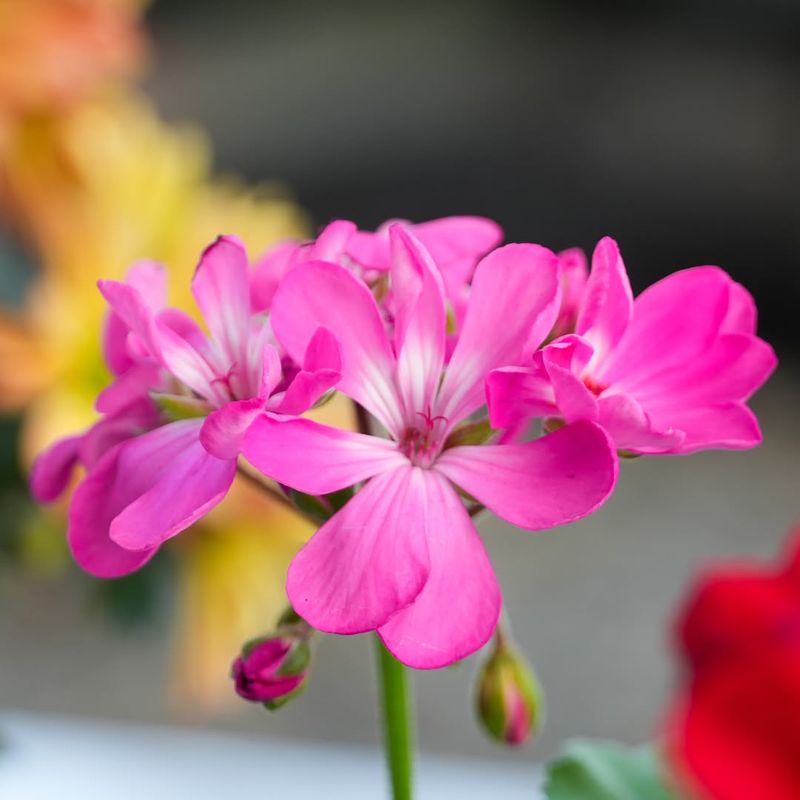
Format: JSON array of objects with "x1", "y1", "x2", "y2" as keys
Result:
[{"x1": 0, "y1": 713, "x2": 538, "y2": 800}]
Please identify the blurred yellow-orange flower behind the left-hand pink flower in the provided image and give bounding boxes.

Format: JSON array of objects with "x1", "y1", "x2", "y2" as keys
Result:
[{"x1": 0, "y1": 90, "x2": 340, "y2": 709}]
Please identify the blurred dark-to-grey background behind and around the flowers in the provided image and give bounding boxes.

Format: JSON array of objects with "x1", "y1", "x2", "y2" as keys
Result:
[{"x1": 0, "y1": 0, "x2": 800, "y2": 776}]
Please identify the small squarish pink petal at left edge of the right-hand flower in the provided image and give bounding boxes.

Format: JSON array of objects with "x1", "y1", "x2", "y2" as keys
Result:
[{"x1": 486, "y1": 367, "x2": 558, "y2": 430}]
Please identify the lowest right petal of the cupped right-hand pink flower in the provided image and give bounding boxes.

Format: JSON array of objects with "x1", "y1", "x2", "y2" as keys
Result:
[{"x1": 650, "y1": 402, "x2": 762, "y2": 453}]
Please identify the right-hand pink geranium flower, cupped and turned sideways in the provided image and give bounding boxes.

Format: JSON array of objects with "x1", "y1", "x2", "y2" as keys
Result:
[{"x1": 487, "y1": 238, "x2": 776, "y2": 453}]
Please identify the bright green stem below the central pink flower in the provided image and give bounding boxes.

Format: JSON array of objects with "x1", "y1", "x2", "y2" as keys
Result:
[{"x1": 375, "y1": 636, "x2": 414, "y2": 800}]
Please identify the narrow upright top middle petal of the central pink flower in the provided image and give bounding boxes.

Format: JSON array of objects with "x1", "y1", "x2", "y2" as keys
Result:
[{"x1": 389, "y1": 225, "x2": 446, "y2": 417}]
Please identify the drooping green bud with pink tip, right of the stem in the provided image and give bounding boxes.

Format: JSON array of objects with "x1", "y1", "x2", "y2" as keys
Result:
[{"x1": 477, "y1": 631, "x2": 542, "y2": 745}]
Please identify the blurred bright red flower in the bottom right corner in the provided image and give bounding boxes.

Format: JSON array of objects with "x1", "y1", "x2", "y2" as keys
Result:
[{"x1": 668, "y1": 529, "x2": 800, "y2": 800}]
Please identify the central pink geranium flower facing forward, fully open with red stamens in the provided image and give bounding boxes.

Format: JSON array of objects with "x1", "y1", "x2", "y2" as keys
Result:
[{"x1": 243, "y1": 225, "x2": 616, "y2": 668}]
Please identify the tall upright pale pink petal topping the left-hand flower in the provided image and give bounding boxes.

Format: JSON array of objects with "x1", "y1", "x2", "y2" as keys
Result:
[{"x1": 192, "y1": 236, "x2": 250, "y2": 368}]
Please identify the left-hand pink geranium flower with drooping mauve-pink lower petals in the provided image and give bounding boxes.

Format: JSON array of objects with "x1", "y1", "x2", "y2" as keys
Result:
[{"x1": 31, "y1": 237, "x2": 339, "y2": 577}]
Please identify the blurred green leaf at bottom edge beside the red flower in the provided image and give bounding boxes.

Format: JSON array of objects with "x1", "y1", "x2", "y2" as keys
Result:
[{"x1": 544, "y1": 740, "x2": 677, "y2": 800}]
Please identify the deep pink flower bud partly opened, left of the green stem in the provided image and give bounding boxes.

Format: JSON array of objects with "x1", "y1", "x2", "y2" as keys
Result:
[{"x1": 231, "y1": 612, "x2": 311, "y2": 711}]
